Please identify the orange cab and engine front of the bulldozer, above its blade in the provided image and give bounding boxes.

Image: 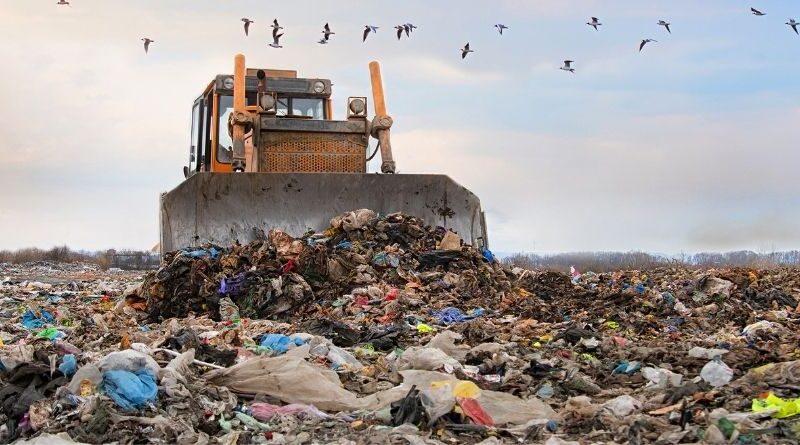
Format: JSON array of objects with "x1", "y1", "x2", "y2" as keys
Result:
[{"x1": 184, "y1": 60, "x2": 378, "y2": 177}]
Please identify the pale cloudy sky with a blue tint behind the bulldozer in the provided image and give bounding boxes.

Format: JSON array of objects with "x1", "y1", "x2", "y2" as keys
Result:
[{"x1": 0, "y1": 0, "x2": 800, "y2": 253}]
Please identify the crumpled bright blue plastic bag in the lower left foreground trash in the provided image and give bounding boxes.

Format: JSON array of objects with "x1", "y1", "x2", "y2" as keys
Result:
[{"x1": 102, "y1": 368, "x2": 158, "y2": 410}]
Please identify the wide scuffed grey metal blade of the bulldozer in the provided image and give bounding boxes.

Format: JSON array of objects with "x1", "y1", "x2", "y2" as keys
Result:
[{"x1": 160, "y1": 173, "x2": 487, "y2": 254}]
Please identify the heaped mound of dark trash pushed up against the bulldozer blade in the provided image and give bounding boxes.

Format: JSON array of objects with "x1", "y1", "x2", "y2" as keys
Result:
[{"x1": 137, "y1": 210, "x2": 589, "y2": 323}]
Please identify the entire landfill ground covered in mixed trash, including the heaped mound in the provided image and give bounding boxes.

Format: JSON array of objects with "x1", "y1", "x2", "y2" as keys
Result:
[{"x1": 0, "y1": 210, "x2": 800, "y2": 445}]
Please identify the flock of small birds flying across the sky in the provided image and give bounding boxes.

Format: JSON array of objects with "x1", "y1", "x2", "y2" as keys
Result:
[{"x1": 56, "y1": 0, "x2": 800, "y2": 73}]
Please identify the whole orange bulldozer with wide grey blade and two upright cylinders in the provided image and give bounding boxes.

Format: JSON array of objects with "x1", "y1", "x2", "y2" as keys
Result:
[{"x1": 159, "y1": 54, "x2": 488, "y2": 255}]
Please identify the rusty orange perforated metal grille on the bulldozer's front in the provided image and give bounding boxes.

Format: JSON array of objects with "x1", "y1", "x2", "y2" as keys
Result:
[{"x1": 259, "y1": 132, "x2": 367, "y2": 173}]
